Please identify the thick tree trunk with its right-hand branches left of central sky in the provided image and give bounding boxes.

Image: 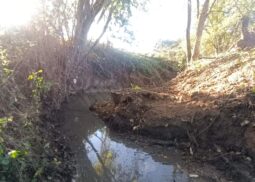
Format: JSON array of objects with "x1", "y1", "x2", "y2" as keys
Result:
[{"x1": 74, "y1": 0, "x2": 148, "y2": 52}]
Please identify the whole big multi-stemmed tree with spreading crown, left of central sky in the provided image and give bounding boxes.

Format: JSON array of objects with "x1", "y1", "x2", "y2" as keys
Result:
[{"x1": 34, "y1": 0, "x2": 146, "y2": 50}]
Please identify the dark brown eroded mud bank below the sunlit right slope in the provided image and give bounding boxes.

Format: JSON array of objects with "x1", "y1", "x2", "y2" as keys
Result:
[{"x1": 91, "y1": 90, "x2": 255, "y2": 181}]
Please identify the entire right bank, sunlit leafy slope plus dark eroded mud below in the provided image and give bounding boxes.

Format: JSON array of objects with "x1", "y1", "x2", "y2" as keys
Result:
[{"x1": 91, "y1": 53, "x2": 255, "y2": 181}]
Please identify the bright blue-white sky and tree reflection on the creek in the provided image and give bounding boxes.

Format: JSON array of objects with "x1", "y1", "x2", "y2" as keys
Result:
[{"x1": 84, "y1": 127, "x2": 189, "y2": 182}]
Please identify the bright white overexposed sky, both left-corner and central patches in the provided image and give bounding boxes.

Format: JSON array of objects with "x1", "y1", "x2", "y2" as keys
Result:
[{"x1": 0, "y1": 0, "x2": 187, "y2": 53}]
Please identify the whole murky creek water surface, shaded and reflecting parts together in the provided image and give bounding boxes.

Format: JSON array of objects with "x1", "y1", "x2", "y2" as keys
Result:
[{"x1": 63, "y1": 94, "x2": 213, "y2": 182}]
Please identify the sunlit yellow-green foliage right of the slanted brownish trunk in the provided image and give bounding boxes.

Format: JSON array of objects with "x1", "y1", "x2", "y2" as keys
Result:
[{"x1": 202, "y1": 0, "x2": 255, "y2": 55}]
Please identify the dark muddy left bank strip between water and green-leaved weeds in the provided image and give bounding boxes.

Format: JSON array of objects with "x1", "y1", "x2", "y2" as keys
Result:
[{"x1": 35, "y1": 108, "x2": 75, "y2": 182}]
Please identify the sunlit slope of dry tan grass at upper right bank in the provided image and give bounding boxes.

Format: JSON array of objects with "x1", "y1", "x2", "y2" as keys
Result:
[{"x1": 172, "y1": 52, "x2": 255, "y2": 95}]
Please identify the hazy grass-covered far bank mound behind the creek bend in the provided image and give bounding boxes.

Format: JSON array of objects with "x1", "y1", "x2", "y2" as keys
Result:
[{"x1": 67, "y1": 47, "x2": 176, "y2": 92}]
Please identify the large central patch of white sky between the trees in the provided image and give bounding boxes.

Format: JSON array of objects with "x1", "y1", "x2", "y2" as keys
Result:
[{"x1": 124, "y1": 0, "x2": 187, "y2": 52}]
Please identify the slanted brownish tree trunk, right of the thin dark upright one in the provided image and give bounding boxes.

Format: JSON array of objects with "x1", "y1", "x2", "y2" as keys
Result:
[{"x1": 192, "y1": 0, "x2": 210, "y2": 61}]
